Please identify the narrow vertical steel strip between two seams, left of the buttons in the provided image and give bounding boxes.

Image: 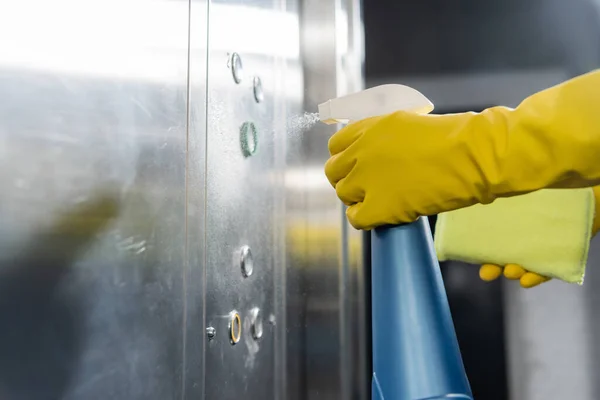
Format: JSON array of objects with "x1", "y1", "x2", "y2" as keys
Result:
[{"x1": 189, "y1": 0, "x2": 208, "y2": 399}]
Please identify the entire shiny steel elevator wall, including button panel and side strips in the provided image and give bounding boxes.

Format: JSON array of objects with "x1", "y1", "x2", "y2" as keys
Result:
[{"x1": 0, "y1": 0, "x2": 368, "y2": 400}]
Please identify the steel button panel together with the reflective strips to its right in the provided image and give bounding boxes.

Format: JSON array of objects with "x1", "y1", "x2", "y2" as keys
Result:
[{"x1": 206, "y1": 0, "x2": 366, "y2": 399}]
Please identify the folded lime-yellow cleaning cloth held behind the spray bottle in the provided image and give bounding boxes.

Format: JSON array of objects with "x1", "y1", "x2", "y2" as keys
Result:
[{"x1": 434, "y1": 189, "x2": 595, "y2": 284}]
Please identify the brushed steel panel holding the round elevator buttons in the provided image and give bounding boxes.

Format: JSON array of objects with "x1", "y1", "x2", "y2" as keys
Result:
[{"x1": 206, "y1": 0, "x2": 294, "y2": 399}]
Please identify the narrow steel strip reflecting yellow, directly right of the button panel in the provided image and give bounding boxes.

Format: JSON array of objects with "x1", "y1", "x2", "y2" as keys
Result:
[{"x1": 301, "y1": 0, "x2": 349, "y2": 399}]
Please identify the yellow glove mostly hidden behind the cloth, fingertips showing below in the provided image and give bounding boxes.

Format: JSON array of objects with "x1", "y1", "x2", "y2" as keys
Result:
[{"x1": 479, "y1": 186, "x2": 600, "y2": 289}]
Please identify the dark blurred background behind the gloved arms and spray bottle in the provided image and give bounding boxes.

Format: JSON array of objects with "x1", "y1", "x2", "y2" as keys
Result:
[{"x1": 363, "y1": 0, "x2": 600, "y2": 400}]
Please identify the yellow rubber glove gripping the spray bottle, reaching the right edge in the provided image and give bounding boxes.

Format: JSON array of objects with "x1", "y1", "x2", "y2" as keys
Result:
[{"x1": 325, "y1": 72, "x2": 600, "y2": 229}]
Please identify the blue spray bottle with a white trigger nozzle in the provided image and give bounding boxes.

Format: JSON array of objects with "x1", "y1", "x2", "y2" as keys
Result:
[{"x1": 319, "y1": 85, "x2": 473, "y2": 400}]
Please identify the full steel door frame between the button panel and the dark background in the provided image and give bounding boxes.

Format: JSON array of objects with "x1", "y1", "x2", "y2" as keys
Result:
[{"x1": 286, "y1": 0, "x2": 367, "y2": 399}]
